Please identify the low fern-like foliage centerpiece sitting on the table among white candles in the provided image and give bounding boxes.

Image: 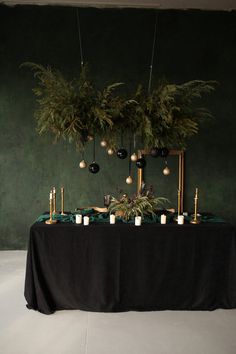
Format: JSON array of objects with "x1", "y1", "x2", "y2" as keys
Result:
[{"x1": 108, "y1": 191, "x2": 168, "y2": 220}]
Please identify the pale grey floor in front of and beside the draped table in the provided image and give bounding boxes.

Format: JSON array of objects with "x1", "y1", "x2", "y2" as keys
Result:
[{"x1": 0, "y1": 251, "x2": 236, "y2": 354}]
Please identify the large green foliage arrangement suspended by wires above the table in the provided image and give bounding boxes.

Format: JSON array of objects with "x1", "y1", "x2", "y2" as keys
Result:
[{"x1": 23, "y1": 63, "x2": 217, "y2": 150}]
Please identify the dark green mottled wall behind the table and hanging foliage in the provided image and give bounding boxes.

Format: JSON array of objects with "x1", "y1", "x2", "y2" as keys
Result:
[{"x1": 0, "y1": 6, "x2": 236, "y2": 249}]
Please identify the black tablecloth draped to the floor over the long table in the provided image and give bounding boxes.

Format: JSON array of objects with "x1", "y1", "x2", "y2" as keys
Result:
[{"x1": 25, "y1": 223, "x2": 236, "y2": 314}]
